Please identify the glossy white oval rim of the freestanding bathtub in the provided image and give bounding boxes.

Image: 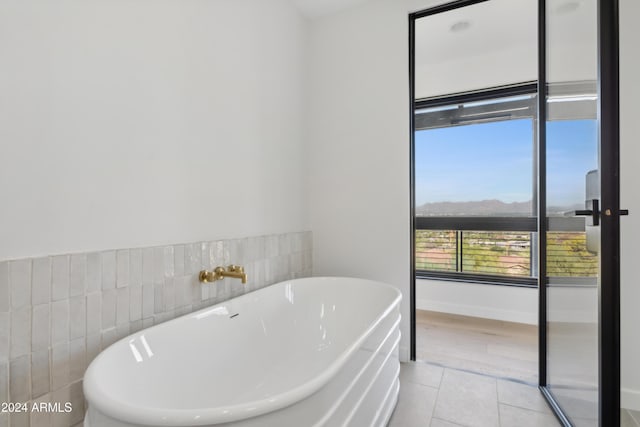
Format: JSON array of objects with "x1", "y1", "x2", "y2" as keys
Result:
[{"x1": 83, "y1": 276, "x2": 402, "y2": 426}]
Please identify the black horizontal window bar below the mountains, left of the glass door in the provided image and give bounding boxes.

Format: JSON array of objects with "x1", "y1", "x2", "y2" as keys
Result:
[{"x1": 415, "y1": 216, "x2": 538, "y2": 232}]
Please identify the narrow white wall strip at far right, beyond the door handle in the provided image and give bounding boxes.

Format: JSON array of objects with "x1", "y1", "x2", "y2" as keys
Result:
[{"x1": 620, "y1": 0, "x2": 640, "y2": 410}]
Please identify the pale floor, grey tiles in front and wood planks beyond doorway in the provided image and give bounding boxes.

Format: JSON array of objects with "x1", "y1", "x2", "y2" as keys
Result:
[{"x1": 396, "y1": 311, "x2": 640, "y2": 427}]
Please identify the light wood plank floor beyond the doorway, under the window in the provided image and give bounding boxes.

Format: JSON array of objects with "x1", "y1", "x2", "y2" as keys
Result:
[{"x1": 416, "y1": 310, "x2": 538, "y2": 384}]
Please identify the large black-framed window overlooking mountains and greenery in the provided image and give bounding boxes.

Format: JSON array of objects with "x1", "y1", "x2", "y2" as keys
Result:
[{"x1": 414, "y1": 86, "x2": 597, "y2": 286}]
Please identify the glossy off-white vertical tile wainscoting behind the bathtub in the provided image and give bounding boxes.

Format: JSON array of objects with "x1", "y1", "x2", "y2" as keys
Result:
[{"x1": 0, "y1": 232, "x2": 312, "y2": 427}]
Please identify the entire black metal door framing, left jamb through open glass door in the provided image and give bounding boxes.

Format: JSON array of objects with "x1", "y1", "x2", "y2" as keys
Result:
[{"x1": 409, "y1": 0, "x2": 620, "y2": 427}]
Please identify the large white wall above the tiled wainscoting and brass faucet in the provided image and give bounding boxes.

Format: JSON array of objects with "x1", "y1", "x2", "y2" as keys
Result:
[{"x1": 0, "y1": 0, "x2": 308, "y2": 260}]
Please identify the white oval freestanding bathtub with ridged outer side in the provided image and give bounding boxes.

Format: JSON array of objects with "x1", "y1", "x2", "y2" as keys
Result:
[{"x1": 84, "y1": 278, "x2": 401, "y2": 427}]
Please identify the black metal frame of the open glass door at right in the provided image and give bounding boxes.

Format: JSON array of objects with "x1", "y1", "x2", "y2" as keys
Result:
[{"x1": 538, "y1": 0, "x2": 620, "y2": 427}]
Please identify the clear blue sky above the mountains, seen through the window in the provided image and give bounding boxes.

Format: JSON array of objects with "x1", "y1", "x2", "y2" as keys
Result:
[{"x1": 415, "y1": 119, "x2": 597, "y2": 206}]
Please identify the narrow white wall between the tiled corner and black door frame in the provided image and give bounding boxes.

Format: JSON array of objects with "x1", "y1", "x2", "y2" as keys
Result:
[{"x1": 308, "y1": 0, "x2": 418, "y2": 358}]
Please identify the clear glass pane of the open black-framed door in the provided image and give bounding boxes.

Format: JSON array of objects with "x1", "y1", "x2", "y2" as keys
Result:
[{"x1": 545, "y1": 0, "x2": 600, "y2": 426}]
